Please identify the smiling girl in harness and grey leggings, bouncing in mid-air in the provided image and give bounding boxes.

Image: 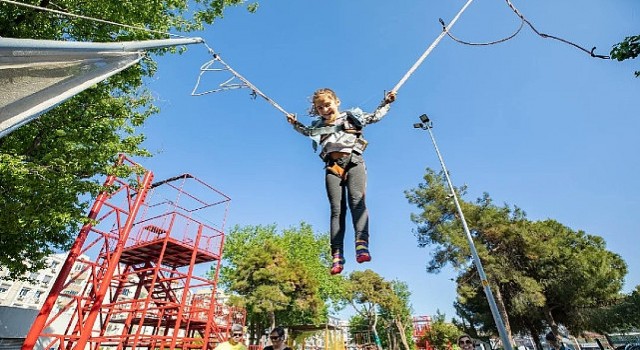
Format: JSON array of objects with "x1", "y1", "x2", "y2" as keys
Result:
[{"x1": 287, "y1": 88, "x2": 396, "y2": 275}]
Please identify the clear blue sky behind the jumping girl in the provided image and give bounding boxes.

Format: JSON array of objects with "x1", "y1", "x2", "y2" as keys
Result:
[{"x1": 136, "y1": 0, "x2": 640, "y2": 317}]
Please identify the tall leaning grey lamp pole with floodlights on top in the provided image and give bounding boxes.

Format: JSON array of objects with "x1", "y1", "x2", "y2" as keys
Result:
[{"x1": 414, "y1": 114, "x2": 513, "y2": 350}]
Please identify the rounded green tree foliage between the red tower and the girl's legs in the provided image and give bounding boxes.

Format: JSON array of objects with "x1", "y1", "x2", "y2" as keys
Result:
[{"x1": 212, "y1": 223, "x2": 343, "y2": 342}]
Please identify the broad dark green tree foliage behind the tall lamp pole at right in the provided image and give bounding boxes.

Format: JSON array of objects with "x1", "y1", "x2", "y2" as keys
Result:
[{"x1": 406, "y1": 169, "x2": 627, "y2": 340}]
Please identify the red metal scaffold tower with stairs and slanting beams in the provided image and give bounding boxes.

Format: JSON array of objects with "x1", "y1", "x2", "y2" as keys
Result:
[{"x1": 23, "y1": 156, "x2": 245, "y2": 350}]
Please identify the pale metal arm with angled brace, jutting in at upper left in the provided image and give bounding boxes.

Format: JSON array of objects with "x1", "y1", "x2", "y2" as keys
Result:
[{"x1": 0, "y1": 38, "x2": 204, "y2": 138}]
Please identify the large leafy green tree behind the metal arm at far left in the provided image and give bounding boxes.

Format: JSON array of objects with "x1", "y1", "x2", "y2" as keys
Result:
[{"x1": 0, "y1": 0, "x2": 257, "y2": 278}]
